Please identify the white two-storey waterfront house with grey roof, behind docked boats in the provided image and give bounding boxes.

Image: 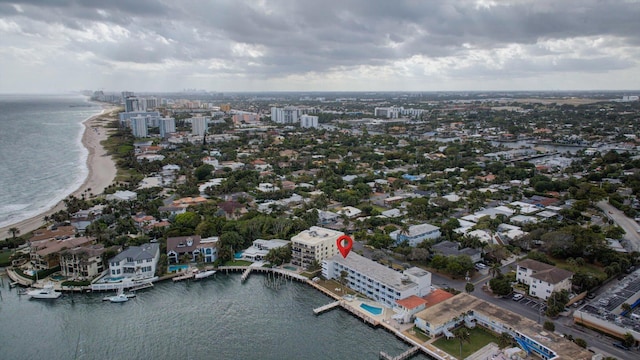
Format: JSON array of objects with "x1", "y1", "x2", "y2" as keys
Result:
[{"x1": 109, "y1": 243, "x2": 160, "y2": 279}]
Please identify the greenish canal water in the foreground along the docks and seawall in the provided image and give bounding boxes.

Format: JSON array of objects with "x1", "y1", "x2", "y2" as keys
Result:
[{"x1": 0, "y1": 273, "x2": 427, "y2": 359}]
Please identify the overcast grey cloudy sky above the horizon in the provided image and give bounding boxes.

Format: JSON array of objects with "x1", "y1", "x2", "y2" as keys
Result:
[{"x1": 0, "y1": 0, "x2": 640, "y2": 93}]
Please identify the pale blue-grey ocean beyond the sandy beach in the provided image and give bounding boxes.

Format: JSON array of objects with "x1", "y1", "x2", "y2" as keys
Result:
[{"x1": 0, "y1": 95, "x2": 102, "y2": 229}]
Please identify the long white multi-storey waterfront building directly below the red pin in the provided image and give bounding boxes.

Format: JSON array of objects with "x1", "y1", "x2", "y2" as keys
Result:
[{"x1": 322, "y1": 252, "x2": 431, "y2": 308}]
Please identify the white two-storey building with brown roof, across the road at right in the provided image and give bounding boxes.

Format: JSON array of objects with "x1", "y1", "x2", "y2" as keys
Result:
[{"x1": 516, "y1": 259, "x2": 573, "y2": 300}]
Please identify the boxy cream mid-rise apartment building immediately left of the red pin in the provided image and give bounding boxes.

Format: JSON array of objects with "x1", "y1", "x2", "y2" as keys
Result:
[{"x1": 291, "y1": 226, "x2": 344, "y2": 269}]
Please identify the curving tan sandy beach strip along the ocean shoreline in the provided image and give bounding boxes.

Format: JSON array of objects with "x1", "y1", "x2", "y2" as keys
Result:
[{"x1": 0, "y1": 104, "x2": 117, "y2": 239}]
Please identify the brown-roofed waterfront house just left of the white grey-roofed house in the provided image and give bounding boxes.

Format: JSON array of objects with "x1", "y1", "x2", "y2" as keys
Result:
[{"x1": 60, "y1": 245, "x2": 104, "y2": 279}]
